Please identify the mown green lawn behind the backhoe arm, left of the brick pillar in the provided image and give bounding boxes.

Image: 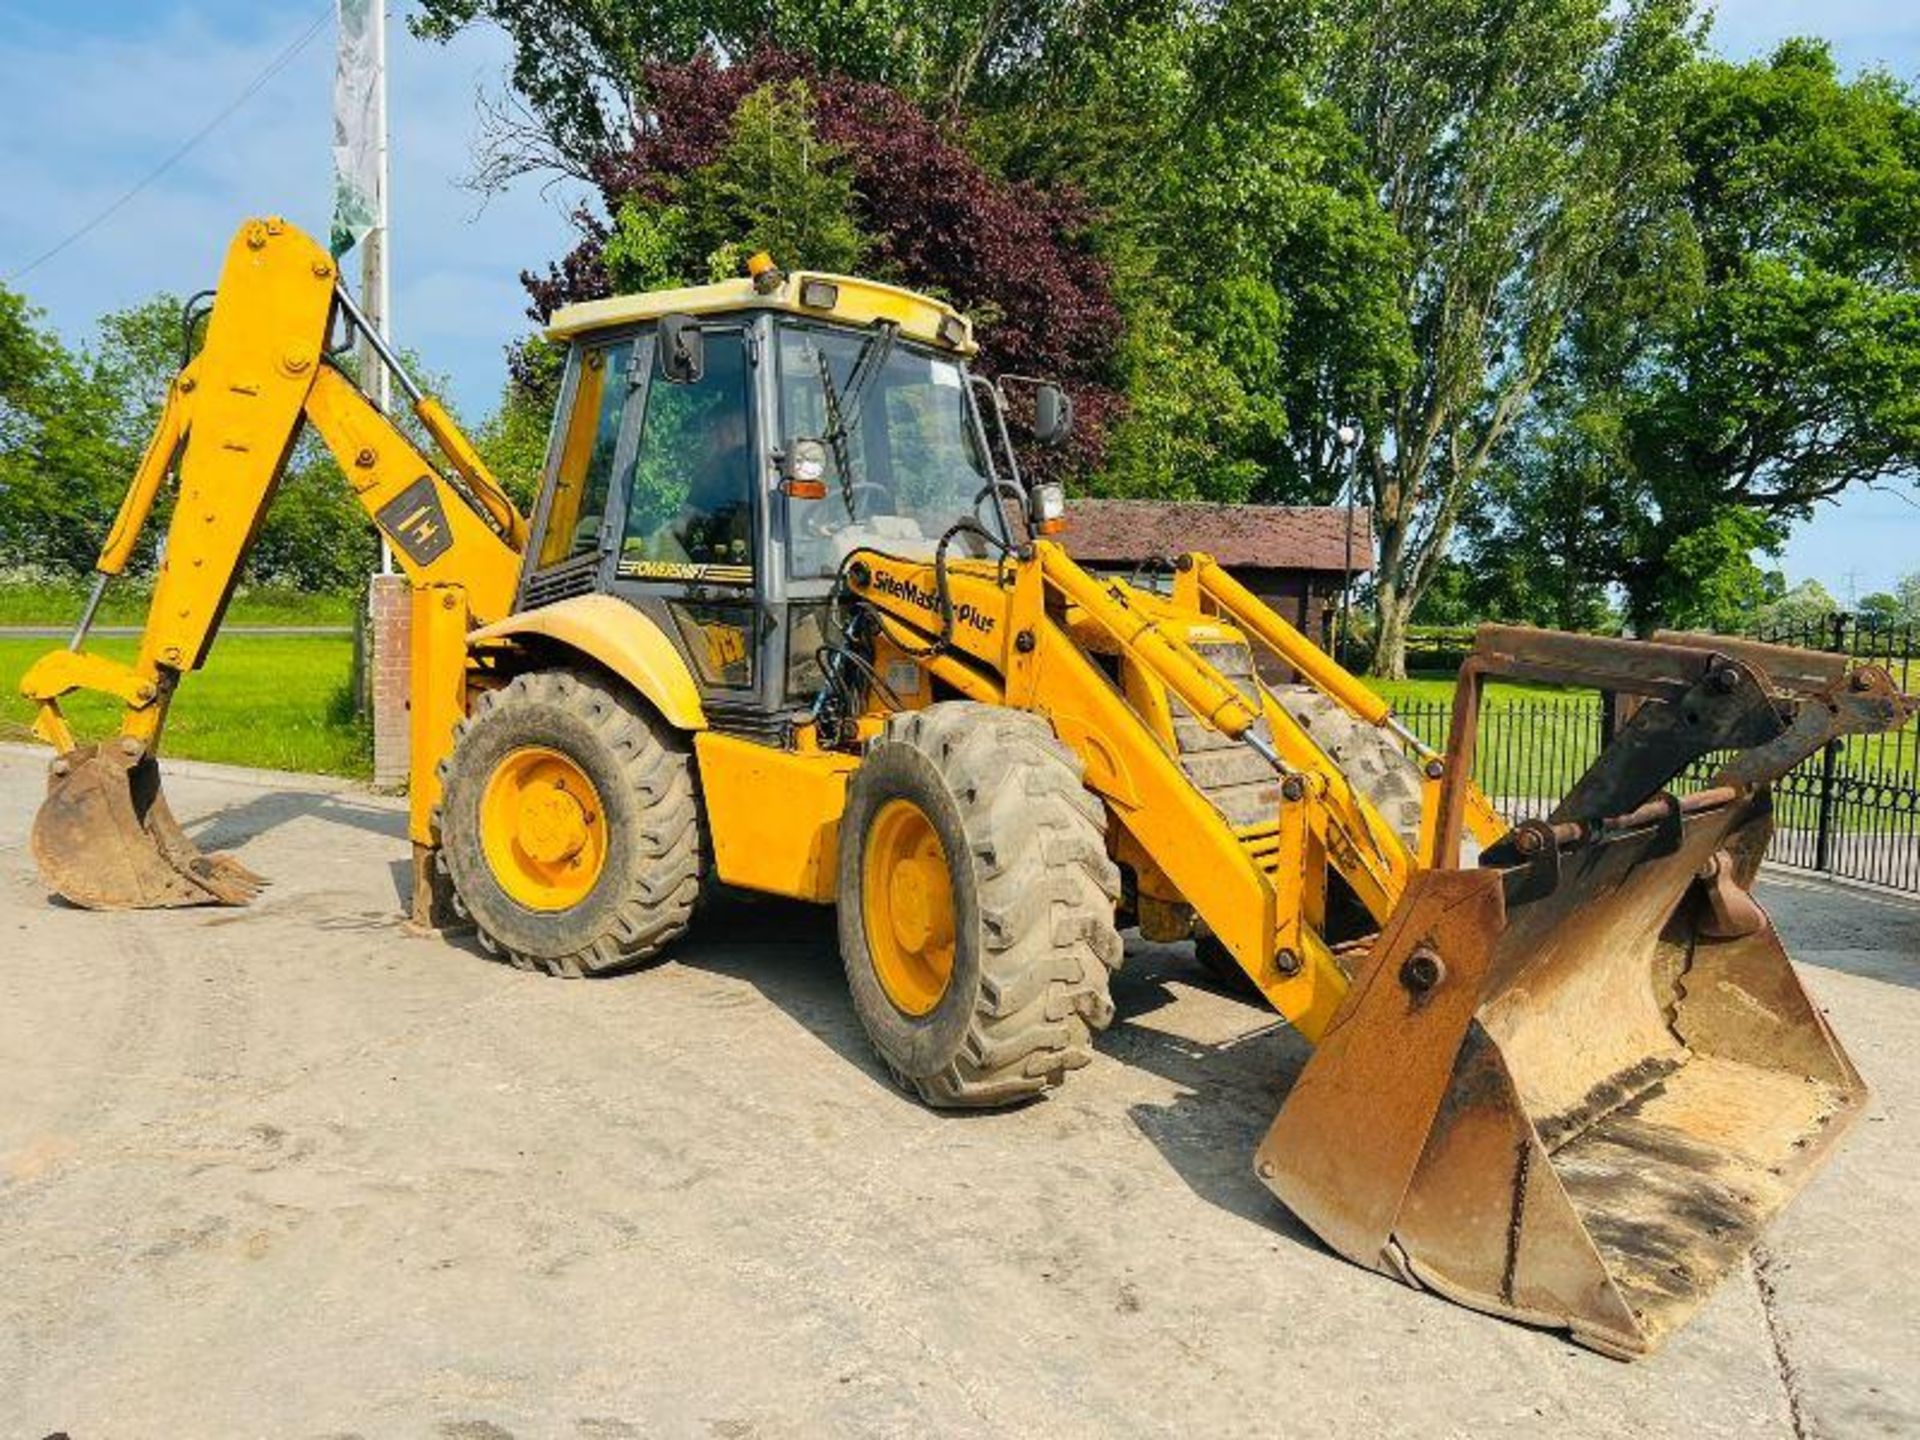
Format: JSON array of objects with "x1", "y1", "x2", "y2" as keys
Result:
[{"x1": 0, "y1": 632, "x2": 372, "y2": 778}]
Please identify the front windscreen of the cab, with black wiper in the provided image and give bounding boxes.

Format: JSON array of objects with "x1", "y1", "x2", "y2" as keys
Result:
[{"x1": 780, "y1": 324, "x2": 1004, "y2": 580}]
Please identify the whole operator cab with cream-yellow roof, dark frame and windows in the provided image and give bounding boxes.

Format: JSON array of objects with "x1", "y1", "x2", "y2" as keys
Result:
[{"x1": 518, "y1": 265, "x2": 1069, "y2": 739}]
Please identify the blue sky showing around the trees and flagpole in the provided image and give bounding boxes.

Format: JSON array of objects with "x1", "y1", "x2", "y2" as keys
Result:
[{"x1": 0, "y1": 0, "x2": 1920, "y2": 601}]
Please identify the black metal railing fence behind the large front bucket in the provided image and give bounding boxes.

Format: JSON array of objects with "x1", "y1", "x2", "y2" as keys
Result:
[{"x1": 1396, "y1": 616, "x2": 1920, "y2": 893}]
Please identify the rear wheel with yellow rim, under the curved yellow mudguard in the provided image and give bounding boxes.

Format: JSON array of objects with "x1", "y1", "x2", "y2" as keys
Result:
[{"x1": 438, "y1": 670, "x2": 703, "y2": 977}]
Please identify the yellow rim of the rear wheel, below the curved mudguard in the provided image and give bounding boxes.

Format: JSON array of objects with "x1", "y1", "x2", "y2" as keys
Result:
[{"x1": 480, "y1": 745, "x2": 607, "y2": 910}]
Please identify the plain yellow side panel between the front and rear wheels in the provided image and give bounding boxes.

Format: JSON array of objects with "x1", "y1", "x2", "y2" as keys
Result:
[{"x1": 693, "y1": 732, "x2": 860, "y2": 904}]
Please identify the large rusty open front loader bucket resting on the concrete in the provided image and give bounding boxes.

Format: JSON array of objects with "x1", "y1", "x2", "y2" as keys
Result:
[{"x1": 1258, "y1": 789, "x2": 1866, "y2": 1357}]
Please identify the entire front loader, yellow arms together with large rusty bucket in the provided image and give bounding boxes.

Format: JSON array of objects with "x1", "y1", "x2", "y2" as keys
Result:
[{"x1": 849, "y1": 541, "x2": 1914, "y2": 1356}]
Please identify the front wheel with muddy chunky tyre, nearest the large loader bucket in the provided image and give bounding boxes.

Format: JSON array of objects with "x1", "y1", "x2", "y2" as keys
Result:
[{"x1": 839, "y1": 701, "x2": 1121, "y2": 1108}]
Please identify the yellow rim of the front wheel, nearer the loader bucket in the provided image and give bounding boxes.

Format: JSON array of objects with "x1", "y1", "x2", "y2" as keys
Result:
[{"x1": 860, "y1": 801, "x2": 954, "y2": 1016}]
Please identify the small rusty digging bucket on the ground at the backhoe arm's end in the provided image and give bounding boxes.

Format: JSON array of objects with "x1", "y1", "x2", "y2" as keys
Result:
[{"x1": 33, "y1": 741, "x2": 267, "y2": 910}]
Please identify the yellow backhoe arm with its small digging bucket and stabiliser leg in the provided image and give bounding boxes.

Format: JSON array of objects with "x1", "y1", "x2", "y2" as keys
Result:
[{"x1": 21, "y1": 219, "x2": 526, "y2": 906}]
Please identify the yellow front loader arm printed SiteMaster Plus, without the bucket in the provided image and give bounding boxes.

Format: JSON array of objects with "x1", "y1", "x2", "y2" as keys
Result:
[{"x1": 849, "y1": 541, "x2": 1443, "y2": 1039}]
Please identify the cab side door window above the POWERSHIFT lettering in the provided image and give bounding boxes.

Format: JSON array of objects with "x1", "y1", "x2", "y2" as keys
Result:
[{"x1": 620, "y1": 328, "x2": 755, "y2": 586}]
